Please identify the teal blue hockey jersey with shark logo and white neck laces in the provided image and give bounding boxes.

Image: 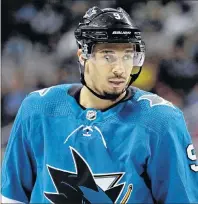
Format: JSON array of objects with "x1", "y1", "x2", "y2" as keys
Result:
[{"x1": 1, "y1": 84, "x2": 198, "y2": 204}]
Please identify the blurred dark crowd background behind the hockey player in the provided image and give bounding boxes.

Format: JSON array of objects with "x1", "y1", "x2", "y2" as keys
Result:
[{"x1": 1, "y1": 0, "x2": 198, "y2": 152}]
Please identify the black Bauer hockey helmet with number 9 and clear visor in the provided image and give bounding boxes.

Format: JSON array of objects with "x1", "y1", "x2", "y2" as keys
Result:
[{"x1": 75, "y1": 6, "x2": 145, "y2": 99}]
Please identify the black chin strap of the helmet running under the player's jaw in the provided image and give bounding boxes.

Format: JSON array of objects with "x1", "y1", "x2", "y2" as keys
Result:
[{"x1": 78, "y1": 61, "x2": 142, "y2": 100}]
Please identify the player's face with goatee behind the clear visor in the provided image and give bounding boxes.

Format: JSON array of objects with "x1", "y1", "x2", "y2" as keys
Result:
[{"x1": 85, "y1": 43, "x2": 134, "y2": 98}]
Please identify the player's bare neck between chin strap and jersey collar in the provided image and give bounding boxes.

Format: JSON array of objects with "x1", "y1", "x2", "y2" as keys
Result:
[{"x1": 79, "y1": 86, "x2": 126, "y2": 110}]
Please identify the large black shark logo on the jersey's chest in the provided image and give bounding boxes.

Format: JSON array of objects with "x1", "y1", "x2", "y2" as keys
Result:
[{"x1": 44, "y1": 147, "x2": 132, "y2": 204}]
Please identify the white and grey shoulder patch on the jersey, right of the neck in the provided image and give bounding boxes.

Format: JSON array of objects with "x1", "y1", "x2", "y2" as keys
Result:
[{"x1": 138, "y1": 94, "x2": 175, "y2": 108}]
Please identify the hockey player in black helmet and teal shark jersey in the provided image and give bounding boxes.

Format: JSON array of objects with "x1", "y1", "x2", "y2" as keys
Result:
[{"x1": 2, "y1": 7, "x2": 198, "y2": 204}]
